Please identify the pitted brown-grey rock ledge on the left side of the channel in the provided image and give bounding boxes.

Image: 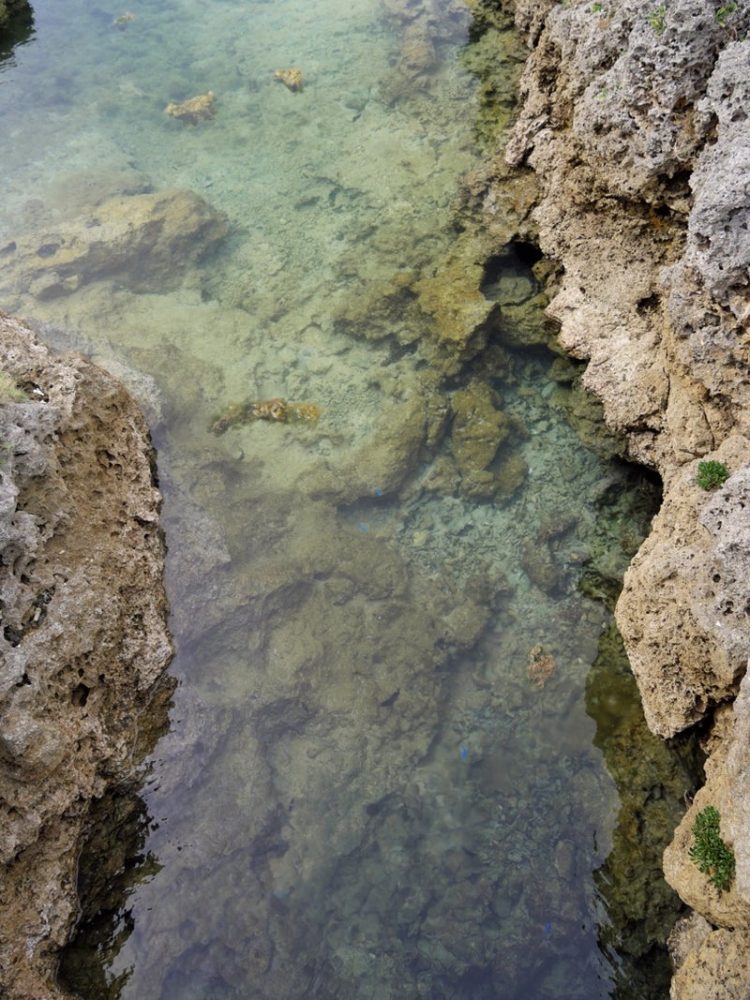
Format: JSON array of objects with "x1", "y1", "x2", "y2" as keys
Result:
[{"x1": 0, "y1": 313, "x2": 171, "y2": 1000}]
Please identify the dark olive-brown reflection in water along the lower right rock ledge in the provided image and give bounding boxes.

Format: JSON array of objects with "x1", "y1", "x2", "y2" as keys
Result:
[{"x1": 586, "y1": 624, "x2": 700, "y2": 1000}]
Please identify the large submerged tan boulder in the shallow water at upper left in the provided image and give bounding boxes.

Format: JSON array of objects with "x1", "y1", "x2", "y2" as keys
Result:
[{"x1": 3, "y1": 191, "x2": 227, "y2": 298}]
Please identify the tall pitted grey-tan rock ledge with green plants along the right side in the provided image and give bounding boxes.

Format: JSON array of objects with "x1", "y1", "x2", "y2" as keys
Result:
[{"x1": 500, "y1": 0, "x2": 750, "y2": 1000}]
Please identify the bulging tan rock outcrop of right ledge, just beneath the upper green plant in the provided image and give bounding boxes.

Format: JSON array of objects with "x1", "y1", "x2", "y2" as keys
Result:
[{"x1": 616, "y1": 437, "x2": 750, "y2": 736}]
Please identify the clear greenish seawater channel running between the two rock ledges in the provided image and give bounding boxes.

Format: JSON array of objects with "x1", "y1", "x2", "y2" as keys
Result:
[{"x1": 0, "y1": 0, "x2": 690, "y2": 1000}]
